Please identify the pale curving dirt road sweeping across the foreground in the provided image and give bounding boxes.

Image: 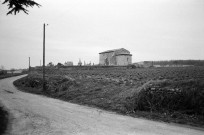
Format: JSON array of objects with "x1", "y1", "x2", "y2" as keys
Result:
[{"x1": 0, "y1": 76, "x2": 204, "y2": 135}]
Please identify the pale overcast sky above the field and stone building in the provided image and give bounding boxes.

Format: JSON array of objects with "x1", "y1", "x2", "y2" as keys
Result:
[{"x1": 0, "y1": 0, "x2": 204, "y2": 69}]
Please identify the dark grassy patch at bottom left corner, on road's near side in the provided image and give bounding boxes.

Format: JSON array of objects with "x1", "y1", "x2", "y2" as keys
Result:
[{"x1": 0, "y1": 107, "x2": 8, "y2": 135}]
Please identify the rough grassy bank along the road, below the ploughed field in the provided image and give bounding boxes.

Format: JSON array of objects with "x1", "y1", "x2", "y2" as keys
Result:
[{"x1": 14, "y1": 73, "x2": 204, "y2": 127}]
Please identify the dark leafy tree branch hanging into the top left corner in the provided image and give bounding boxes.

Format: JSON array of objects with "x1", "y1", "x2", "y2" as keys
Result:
[{"x1": 2, "y1": 0, "x2": 41, "y2": 15}]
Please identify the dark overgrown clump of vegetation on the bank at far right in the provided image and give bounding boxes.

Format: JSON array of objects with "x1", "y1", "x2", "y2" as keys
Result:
[{"x1": 135, "y1": 80, "x2": 204, "y2": 115}]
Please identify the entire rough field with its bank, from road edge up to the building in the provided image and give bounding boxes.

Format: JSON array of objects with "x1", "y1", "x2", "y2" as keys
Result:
[{"x1": 14, "y1": 67, "x2": 204, "y2": 127}]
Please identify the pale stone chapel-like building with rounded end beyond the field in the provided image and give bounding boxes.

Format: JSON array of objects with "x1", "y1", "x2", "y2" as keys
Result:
[{"x1": 99, "y1": 48, "x2": 132, "y2": 66}]
